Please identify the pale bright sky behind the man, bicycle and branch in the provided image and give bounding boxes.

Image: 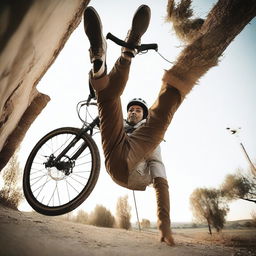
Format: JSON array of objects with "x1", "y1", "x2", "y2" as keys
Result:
[{"x1": 2, "y1": 0, "x2": 256, "y2": 222}]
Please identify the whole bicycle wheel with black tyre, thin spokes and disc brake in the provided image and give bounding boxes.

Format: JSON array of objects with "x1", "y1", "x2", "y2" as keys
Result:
[{"x1": 23, "y1": 127, "x2": 100, "y2": 216}]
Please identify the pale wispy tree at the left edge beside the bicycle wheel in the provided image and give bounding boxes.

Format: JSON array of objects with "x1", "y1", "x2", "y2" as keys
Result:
[{"x1": 0, "y1": 153, "x2": 23, "y2": 210}]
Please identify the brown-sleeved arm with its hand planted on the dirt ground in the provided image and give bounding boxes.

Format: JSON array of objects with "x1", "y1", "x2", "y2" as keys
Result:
[{"x1": 153, "y1": 177, "x2": 174, "y2": 246}]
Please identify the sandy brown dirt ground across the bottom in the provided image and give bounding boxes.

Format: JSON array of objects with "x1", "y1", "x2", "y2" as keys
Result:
[{"x1": 0, "y1": 206, "x2": 256, "y2": 256}]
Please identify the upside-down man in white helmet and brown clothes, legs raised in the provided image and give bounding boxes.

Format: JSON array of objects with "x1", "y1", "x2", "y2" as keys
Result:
[{"x1": 84, "y1": 5, "x2": 188, "y2": 246}]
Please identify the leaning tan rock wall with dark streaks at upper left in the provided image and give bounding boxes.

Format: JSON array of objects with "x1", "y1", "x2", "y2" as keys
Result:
[{"x1": 0, "y1": 0, "x2": 89, "y2": 170}]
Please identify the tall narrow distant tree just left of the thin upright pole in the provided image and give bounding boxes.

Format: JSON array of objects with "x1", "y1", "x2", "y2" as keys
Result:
[{"x1": 116, "y1": 195, "x2": 131, "y2": 229}]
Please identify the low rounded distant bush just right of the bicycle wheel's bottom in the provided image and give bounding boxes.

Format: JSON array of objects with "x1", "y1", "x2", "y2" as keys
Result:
[{"x1": 88, "y1": 205, "x2": 115, "y2": 228}]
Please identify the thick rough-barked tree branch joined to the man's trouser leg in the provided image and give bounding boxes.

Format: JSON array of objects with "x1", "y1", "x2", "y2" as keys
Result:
[{"x1": 163, "y1": 0, "x2": 256, "y2": 96}]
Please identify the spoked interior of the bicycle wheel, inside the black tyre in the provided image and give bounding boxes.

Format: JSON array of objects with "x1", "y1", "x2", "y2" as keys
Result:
[{"x1": 29, "y1": 133, "x2": 93, "y2": 208}]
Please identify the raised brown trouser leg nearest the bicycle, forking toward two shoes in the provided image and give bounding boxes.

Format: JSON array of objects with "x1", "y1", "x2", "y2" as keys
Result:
[{"x1": 90, "y1": 57, "x2": 131, "y2": 186}]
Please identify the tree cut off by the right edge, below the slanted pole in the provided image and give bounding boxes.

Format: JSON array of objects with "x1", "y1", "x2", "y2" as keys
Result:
[{"x1": 221, "y1": 170, "x2": 256, "y2": 203}]
